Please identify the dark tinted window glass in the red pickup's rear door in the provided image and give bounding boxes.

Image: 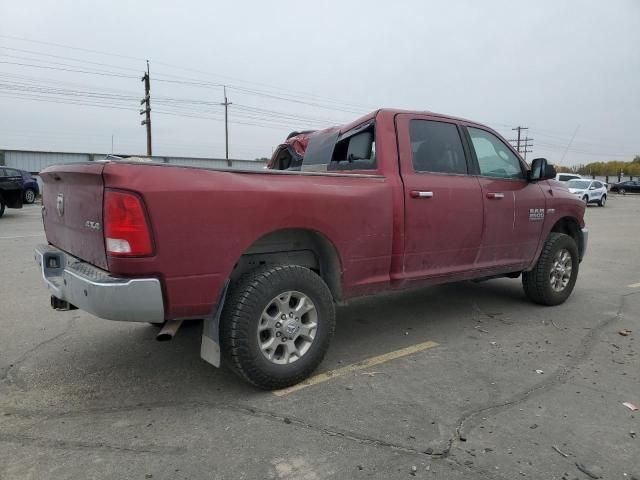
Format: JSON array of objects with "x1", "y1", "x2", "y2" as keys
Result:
[{"x1": 409, "y1": 120, "x2": 468, "y2": 175}]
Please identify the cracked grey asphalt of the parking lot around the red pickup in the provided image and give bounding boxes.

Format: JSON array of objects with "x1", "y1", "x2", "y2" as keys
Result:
[{"x1": 0, "y1": 196, "x2": 640, "y2": 480}]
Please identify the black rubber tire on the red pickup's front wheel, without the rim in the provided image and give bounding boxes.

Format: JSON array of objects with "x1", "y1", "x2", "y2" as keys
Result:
[{"x1": 522, "y1": 232, "x2": 580, "y2": 305}]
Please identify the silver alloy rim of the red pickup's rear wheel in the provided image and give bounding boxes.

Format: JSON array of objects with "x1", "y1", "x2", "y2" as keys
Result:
[{"x1": 258, "y1": 291, "x2": 318, "y2": 365}]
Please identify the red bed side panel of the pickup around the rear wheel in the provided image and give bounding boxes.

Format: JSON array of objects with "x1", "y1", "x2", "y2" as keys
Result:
[{"x1": 103, "y1": 163, "x2": 393, "y2": 318}]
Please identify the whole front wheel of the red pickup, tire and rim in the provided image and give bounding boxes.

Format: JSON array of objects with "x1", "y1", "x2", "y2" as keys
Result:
[{"x1": 522, "y1": 232, "x2": 580, "y2": 305}]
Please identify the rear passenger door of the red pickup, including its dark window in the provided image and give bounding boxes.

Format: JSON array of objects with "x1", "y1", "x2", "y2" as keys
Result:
[{"x1": 396, "y1": 114, "x2": 483, "y2": 279}]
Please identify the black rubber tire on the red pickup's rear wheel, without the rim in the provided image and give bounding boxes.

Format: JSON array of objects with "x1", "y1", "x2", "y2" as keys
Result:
[{"x1": 220, "y1": 265, "x2": 335, "y2": 390}]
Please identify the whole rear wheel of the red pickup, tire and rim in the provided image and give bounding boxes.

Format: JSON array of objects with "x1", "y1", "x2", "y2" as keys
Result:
[{"x1": 220, "y1": 265, "x2": 335, "y2": 390}]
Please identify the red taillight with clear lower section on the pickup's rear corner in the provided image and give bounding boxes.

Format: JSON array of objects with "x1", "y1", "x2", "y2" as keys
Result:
[{"x1": 104, "y1": 190, "x2": 153, "y2": 257}]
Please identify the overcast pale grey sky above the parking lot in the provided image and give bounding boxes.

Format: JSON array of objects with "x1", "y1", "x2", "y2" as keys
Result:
[{"x1": 0, "y1": 0, "x2": 640, "y2": 165}]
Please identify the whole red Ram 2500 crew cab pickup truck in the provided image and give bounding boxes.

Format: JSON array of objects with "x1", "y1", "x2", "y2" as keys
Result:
[{"x1": 36, "y1": 110, "x2": 587, "y2": 389}]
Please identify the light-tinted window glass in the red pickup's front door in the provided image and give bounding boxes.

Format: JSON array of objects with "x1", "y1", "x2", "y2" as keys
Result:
[{"x1": 467, "y1": 127, "x2": 524, "y2": 178}]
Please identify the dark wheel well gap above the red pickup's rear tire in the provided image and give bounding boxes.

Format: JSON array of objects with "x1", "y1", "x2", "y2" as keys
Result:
[{"x1": 231, "y1": 228, "x2": 342, "y2": 301}]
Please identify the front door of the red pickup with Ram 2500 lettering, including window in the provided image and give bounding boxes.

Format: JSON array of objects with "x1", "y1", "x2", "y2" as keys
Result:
[{"x1": 465, "y1": 126, "x2": 546, "y2": 271}]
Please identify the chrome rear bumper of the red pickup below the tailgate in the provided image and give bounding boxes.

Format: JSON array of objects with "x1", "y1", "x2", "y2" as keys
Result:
[{"x1": 35, "y1": 245, "x2": 164, "y2": 323}]
